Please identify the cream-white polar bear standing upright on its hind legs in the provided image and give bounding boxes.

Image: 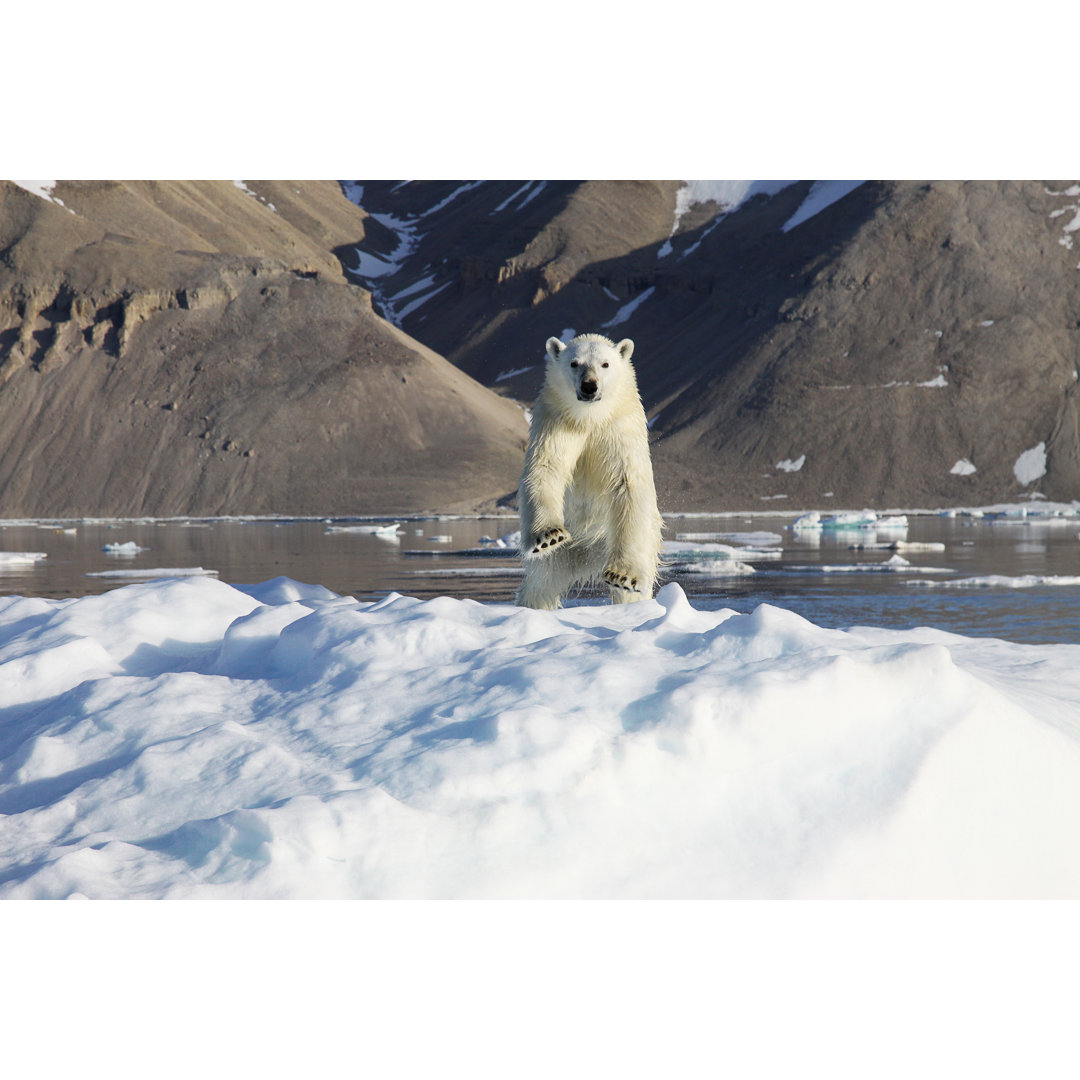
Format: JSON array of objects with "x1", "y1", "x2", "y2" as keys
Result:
[{"x1": 517, "y1": 334, "x2": 663, "y2": 609}]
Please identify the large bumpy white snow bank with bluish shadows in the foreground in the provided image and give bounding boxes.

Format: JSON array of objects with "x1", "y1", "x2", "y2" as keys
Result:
[{"x1": 0, "y1": 578, "x2": 1080, "y2": 897}]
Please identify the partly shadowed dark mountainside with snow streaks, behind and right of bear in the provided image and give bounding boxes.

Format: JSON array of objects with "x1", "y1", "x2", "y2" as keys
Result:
[{"x1": 338, "y1": 181, "x2": 1080, "y2": 510}]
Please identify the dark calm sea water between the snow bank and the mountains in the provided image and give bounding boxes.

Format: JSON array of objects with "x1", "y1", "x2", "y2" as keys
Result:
[{"x1": 0, "y1": 514, "x2": 1080, "y2": 644}]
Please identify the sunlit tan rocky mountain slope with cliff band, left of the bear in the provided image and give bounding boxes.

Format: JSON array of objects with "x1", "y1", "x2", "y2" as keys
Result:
[{"x1": 0, "y1": 181, "x2": 527, "y2": 517}]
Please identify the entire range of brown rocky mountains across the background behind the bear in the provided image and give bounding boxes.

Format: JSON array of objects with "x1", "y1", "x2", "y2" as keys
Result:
[{"x1": 0, "y1": 180, "x2": 1080, "y2": 517}]
